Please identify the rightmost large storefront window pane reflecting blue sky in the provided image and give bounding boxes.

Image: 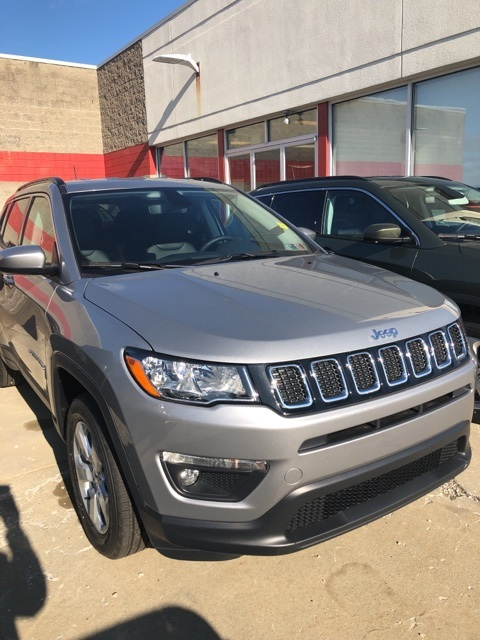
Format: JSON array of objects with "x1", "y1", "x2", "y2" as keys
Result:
[{"x1": 414, "y1": 68, "x2": 480, "y2": 185}]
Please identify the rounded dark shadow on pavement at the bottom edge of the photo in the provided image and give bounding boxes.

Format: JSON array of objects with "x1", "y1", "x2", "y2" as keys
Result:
[{"x1": 82, "y1": 607, "x2": 221, "y2": 640}]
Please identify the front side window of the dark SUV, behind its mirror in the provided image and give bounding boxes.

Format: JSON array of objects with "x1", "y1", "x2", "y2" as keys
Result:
[{"x1": 321, "y1": 189, "x2": 399, "y2": 240}]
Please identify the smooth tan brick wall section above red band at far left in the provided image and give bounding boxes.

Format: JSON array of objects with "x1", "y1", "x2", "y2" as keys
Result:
[{"x1": 0, "y1": 57, "x2": 103, "y2": 154}]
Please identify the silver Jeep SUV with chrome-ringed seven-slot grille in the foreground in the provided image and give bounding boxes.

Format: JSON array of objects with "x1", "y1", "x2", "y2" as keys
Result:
[{"x1": 0, "y1": 178, "x2": 475, "y2": 558}]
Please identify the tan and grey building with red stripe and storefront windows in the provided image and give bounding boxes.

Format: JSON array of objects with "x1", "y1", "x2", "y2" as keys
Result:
[{"x1": 0, "y1": 0, "x2": 480, "y2": 206}]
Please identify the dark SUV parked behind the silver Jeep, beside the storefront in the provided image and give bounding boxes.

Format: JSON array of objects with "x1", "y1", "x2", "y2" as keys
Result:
[{"x1": 252, "y1": 176, "x2": 480, "y2": 338}]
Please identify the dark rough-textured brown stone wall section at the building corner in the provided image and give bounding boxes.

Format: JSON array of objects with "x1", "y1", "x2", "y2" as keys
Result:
[{"x1": 98, "y1": 41, "x2": 148, "y2": 153}]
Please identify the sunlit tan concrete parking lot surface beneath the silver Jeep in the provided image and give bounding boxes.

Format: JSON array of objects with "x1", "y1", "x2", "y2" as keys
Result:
[{"x1": 0, "y1": 385, "x2": 480, "y2": 640}]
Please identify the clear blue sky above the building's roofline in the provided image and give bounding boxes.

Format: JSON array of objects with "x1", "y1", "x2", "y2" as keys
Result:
[{"x1": 0, "y1": 0, "x2": 185, "y2": 65}]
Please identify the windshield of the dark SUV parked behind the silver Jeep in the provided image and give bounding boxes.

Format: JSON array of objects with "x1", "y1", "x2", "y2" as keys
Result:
[{"x1": 380, "y1": 183, "x2": 480, "y2": 237}]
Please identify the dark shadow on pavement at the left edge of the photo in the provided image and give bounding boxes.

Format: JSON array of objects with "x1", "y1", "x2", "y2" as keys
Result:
[{"x1": 0, "y1": 485, "x2": 47, "y2": 640}]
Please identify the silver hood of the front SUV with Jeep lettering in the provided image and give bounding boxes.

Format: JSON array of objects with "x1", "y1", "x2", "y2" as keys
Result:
[{"x1": 85, "y1": 255, "x2": 458, "y2": 363}]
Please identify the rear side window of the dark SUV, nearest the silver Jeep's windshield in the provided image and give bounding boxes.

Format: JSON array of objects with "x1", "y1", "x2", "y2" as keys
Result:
[{"x1": 269, "y1": 189, "x2": 324, "y2": 229}]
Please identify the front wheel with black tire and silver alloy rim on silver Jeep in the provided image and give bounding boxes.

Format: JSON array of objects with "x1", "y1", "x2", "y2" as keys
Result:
[{"x1": 66, "y1": 395, "x2": 145, "y2": 559}]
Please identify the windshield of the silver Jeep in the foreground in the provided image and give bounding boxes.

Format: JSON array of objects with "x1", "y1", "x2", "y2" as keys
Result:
[{"x1": 67, "y1": 185, "x2": 317, "y2": 270}]
